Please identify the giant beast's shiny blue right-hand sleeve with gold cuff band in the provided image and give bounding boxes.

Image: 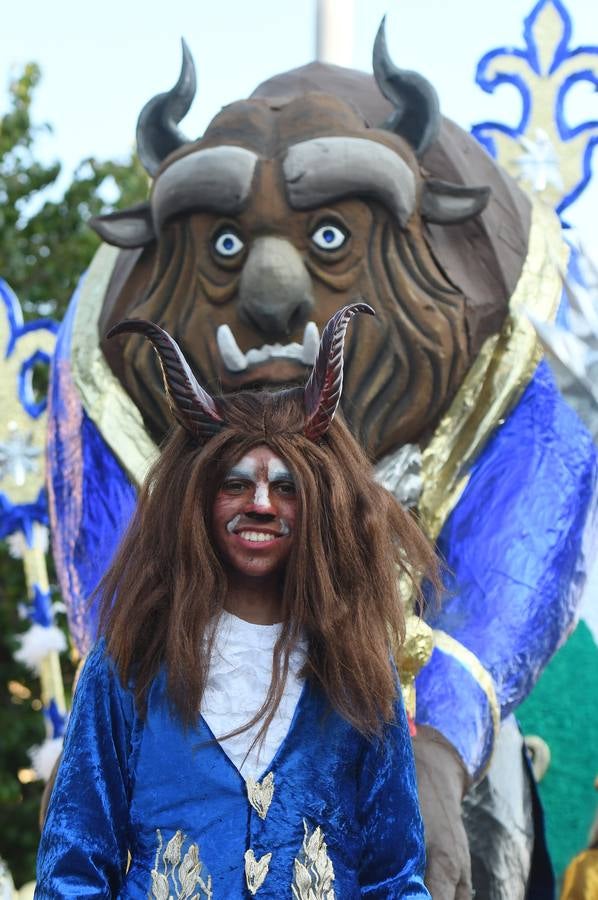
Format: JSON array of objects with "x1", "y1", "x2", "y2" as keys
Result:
[{"x1": 416, "y1": 364, "x2": 596, "y2": 778}]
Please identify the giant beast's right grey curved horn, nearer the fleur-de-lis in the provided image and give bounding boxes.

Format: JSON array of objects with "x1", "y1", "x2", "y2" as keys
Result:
[{"x1": 372, "y1": 16, "x2": 441, "y2": 156}]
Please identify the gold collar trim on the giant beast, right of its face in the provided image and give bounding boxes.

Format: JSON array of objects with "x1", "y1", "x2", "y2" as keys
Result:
[{"x1": 418, "y1": 202, "x2": 569, "y2": 540}]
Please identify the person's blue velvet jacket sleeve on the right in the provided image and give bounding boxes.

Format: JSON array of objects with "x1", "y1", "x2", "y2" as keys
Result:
[{"x1": 357, "y1": 692, "x2": 430, "y2": 900}]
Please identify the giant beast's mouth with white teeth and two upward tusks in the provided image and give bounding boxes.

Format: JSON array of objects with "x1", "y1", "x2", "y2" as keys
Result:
[{"x1": 216, "y1": 322, "x2": 320, "y2": 375}]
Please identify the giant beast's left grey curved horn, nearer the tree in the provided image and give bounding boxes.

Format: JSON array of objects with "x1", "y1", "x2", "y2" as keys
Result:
[{"x1": 137, "y1": 39, "x2": 196, "y2": 177}]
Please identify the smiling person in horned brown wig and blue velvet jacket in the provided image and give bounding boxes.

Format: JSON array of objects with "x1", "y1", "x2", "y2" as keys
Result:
[{"x1": 36, "y1": 303, "x2": 436, "y2": 900}]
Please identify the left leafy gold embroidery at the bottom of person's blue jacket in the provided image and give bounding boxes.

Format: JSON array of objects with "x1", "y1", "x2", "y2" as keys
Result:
[{"x1": 148, "y1": 828, "x2": 213, "y2": 900}]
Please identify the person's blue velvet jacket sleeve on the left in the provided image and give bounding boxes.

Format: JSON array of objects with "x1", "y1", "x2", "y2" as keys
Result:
[{"x1": 35, "y1": 644, "x2": 133, "y2": 900}]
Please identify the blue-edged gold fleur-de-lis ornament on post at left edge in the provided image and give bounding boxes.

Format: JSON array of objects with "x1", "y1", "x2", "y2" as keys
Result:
[{"x1": 0, "y1": 279, "x2": 66, "y2": 774}]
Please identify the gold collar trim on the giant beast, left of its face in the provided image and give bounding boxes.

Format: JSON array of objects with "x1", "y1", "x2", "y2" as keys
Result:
[{"x1": 71, "y1": 244, "x2": 158, "y2": 485}]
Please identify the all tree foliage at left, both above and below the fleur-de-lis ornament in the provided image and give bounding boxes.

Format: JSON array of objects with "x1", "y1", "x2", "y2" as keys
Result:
[{"x1": 0, "y1": 64, "x2": 148, "y2": 887}]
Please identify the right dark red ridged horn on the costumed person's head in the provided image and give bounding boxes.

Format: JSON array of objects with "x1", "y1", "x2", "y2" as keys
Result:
[{"x1": 303, "y1": 303, "x2": 376, "y2": 441}]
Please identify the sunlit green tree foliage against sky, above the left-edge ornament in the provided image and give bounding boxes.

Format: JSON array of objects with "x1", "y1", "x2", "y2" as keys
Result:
[{"x1": 0, "y1": 63, "x2": 148, "y2": 318}]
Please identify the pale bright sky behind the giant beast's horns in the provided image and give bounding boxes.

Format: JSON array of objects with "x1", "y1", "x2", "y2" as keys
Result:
[{"x1": 0, "y1": 0, "x2": 598, "y2": 258}]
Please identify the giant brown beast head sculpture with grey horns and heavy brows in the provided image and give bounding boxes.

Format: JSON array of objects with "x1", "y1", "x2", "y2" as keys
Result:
[{"x1": 94, "y1": 26, "x2": 525, "y2": 458}]
